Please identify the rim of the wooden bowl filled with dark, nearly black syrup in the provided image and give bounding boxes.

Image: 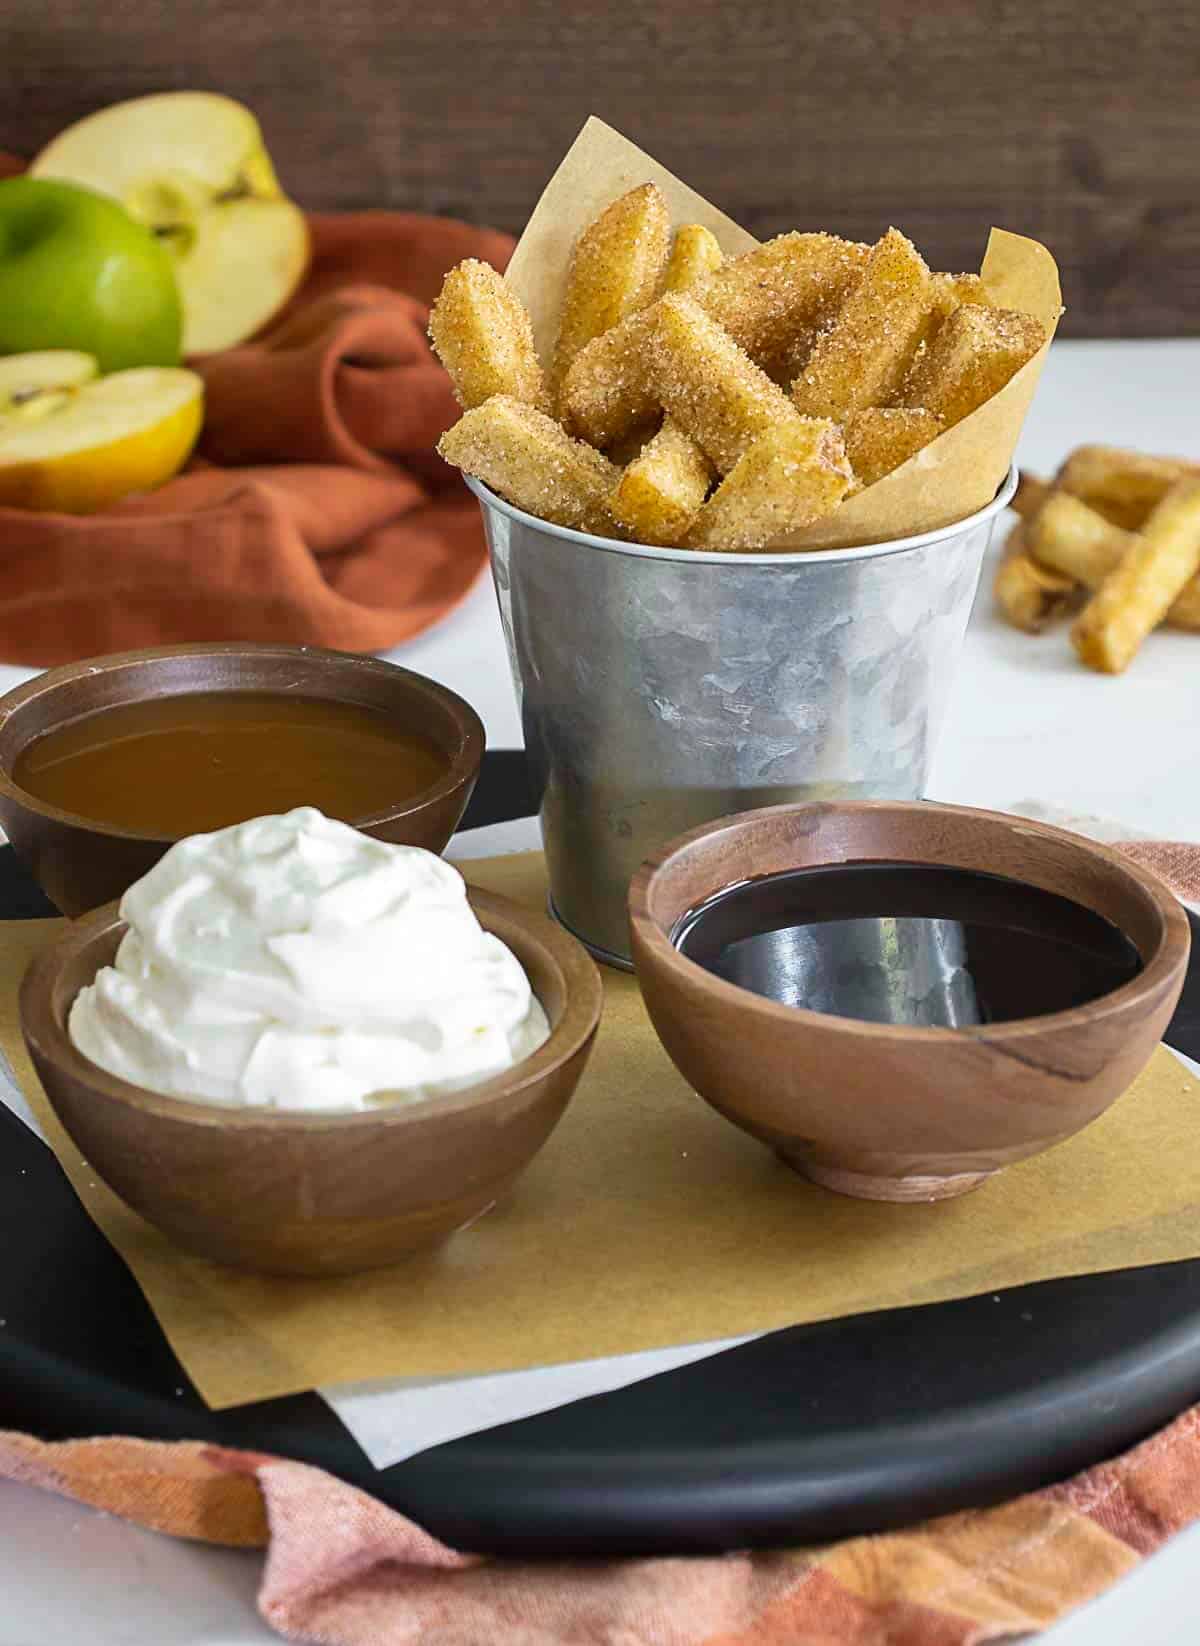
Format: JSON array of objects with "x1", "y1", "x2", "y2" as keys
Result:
[{"x1": 629, "y1": 800, "x2": 1192, "y2": 1047}]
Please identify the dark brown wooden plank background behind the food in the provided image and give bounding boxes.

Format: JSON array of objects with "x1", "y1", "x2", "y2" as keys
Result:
[{"x1": 0, "y1": 0, "x2": 1200, "y2": 336}]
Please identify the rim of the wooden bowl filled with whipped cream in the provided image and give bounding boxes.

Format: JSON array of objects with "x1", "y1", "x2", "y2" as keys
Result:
[{"x1": 18, "y1": 884, "x2": 604, "y2": 1136}]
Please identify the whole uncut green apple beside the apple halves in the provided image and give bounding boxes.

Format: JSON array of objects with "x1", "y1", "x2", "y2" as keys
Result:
[{"x1": 0, "y1": 178, "x2": 183, "y2": 372}]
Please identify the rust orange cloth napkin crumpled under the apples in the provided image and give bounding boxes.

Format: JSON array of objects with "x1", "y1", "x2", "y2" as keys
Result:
[{"x1": 0, "y1": 156, "x2": 512, "y2": 667}]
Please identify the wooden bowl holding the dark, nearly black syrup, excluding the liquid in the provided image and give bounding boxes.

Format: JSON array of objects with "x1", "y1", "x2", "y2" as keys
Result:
[{"x1": 629, "y1": 802, "x2": 1188, "y2": 1200}]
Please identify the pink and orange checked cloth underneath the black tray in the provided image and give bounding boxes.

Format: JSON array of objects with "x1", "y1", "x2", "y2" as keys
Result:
[{"x1": 0, "y1": 841, "x2": 1200, "y2": 1646}]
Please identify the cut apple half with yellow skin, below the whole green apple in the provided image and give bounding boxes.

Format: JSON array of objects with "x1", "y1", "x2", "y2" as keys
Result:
[{"x1": 0, "y1": 363, "x2": 204, "y2": 514}]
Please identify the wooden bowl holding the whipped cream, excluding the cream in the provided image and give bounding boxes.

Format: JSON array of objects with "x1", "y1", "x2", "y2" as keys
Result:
[{"x1": 20, "y1": 889, "x2": 602, "y2": 1274}]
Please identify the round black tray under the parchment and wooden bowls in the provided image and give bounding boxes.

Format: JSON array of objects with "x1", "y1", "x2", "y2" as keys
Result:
[{"x1": 0, "y1": 752, "x2": 1200, "y2": 1555}]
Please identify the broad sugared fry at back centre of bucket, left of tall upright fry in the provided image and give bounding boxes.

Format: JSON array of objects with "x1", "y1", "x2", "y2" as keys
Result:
[{"x1": 701, "y1": 234, "x2": 869, "y2": 365}]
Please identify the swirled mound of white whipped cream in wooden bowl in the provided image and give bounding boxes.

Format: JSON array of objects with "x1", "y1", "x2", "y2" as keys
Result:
[{"x1": 67, "y1": 807, "x2": 550, "y2": 1109}]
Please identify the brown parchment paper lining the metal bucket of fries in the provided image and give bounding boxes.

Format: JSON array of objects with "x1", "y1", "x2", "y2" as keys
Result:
[{"x1": 505, "y1": 115, "x2": 1062, "y2": 550}]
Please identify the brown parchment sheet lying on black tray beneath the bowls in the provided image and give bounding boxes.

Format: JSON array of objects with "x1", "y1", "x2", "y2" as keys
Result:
[{"x1": 0, "y1": 854, "x2": 1200, "y2": 1407}]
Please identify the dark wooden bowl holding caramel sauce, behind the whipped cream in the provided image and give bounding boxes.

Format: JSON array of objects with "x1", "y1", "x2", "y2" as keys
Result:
[{"x1": 0, "y1": 645, "x2": 484, "y2": 917}]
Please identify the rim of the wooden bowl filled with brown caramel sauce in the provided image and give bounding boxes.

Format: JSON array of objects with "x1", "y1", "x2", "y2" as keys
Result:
[{"x1": 0, "y1": 640, "x2": 487, "y2": 846}]
